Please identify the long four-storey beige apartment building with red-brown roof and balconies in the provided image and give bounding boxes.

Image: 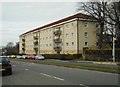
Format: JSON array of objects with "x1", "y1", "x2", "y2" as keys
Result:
[{"x1": 20, "y1": 13, "x2": 98, "y2": 54}]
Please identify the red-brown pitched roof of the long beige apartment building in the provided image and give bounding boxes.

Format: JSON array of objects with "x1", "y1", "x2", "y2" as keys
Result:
[{"x1": 20, "y1": 13, "x2": 93, "y2": 36}]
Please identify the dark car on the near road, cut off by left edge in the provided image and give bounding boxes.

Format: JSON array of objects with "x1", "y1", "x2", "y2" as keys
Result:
[{"x1": 0, "y1": 56, "x2": 12, "y2": 75}]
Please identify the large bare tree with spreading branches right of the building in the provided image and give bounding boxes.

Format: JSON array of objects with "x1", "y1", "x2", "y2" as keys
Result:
[{"x1": 77, "y1": 1, "x2": 120, "y2": 48}]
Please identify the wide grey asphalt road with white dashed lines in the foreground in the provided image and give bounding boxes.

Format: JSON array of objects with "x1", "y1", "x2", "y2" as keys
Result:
[{"x1": 0, "y1": 61, "x2": 118, "y2": 87}]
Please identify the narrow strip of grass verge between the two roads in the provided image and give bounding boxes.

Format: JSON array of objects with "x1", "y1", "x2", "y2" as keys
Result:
[{"x1": 12, "y1": 59, "x2": 120, "y2": 73}]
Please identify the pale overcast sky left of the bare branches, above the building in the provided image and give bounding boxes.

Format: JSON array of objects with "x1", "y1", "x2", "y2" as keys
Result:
[{"x1": 0, "y1": 2, "x2": 83, "y2": 46}]
